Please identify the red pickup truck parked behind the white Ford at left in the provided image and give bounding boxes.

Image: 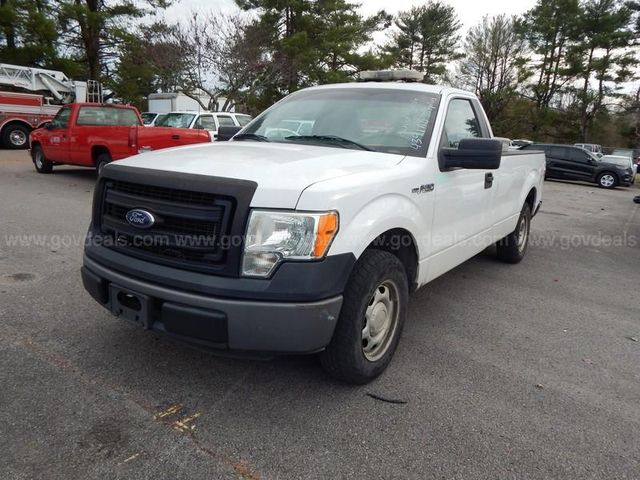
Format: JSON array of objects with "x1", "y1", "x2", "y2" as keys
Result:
[{"x1": 30, "y1": 103, "x2": 211, "y2": 173}]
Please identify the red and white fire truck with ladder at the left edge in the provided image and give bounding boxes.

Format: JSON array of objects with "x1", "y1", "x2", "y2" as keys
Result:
[{"x1": 0, "y1": 63, "x2": 102, "y2": 149}]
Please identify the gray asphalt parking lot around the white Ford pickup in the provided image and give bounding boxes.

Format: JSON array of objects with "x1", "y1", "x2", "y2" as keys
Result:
[{"x1": 0, "y1": 151, "x2": 640, "y2": 480}]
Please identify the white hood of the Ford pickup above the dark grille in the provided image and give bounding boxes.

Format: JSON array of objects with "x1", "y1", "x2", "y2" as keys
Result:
[{"x1": 106, "y1": 141, "x2": 404, "y2": 208}]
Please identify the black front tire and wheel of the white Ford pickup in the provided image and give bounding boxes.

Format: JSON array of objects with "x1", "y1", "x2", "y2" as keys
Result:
[{"x1": 319, "y1": 250, "x2": 409, "y2": 385}]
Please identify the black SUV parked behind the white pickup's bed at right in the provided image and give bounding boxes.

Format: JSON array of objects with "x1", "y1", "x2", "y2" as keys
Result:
[{"x1": 522, "y1": 143, "x2": 634, "y2": 188}]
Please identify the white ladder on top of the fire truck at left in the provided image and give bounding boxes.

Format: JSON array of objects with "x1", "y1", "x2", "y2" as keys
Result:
[{"x1": 0, "y1": 63, "x2": 103, "y2": 103}]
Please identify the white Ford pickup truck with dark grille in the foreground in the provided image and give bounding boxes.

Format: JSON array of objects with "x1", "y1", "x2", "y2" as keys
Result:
[{"x1": 82, "y1": 71, "x2": 545, "y2": 384}]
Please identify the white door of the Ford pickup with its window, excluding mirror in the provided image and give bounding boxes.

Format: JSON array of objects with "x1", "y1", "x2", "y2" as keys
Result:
[{"x1": 429, "y1": 98, "x2": 498, "y2": 278}]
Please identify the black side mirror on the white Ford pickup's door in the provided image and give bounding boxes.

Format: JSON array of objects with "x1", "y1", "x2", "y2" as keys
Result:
[{"x1": 438, "y1": 138, "x2": 502, "y2": 171}]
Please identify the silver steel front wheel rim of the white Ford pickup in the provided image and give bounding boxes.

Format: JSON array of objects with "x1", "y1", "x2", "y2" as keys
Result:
[{"x1": 362, "y1": 280, "x2": 400, "y2": 362}]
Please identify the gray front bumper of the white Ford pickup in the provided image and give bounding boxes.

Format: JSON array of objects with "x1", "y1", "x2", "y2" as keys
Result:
[{"x1": 82, "y1": 255, "x2": 342, "y2": 353}]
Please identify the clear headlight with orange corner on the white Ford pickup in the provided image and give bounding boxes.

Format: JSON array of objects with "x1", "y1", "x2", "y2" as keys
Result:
[{"x1": 242, "y1": 210, "x2": 338, "y2": 277}]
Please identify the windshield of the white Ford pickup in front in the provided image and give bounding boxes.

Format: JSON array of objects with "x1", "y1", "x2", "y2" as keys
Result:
[{"x1": 242, "y1": 87, "x2": 440, "y2": 157}]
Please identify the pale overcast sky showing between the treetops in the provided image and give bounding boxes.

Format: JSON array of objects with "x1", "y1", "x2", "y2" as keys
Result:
[{"x1": 162, "y1": 0, "x2": 535, "y2": 31}]
